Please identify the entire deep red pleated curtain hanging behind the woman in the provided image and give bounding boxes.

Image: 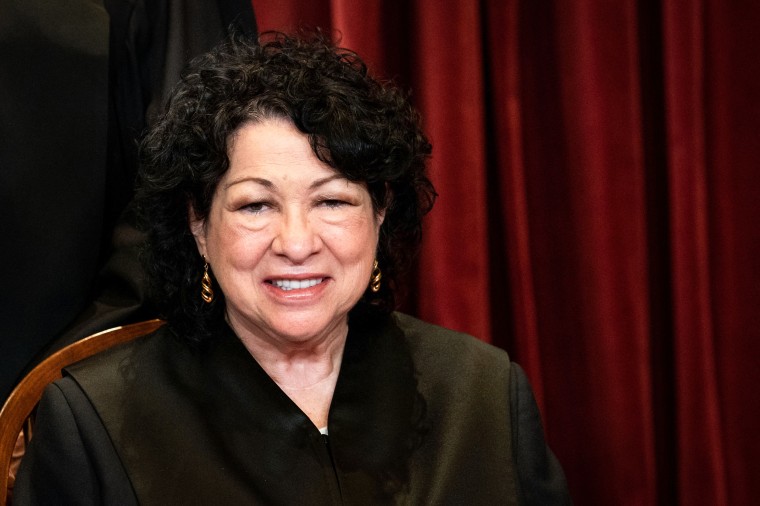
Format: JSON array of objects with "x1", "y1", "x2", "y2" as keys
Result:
[{"x1": 253, "y1": 0, "x2": 760, "y2": 506}]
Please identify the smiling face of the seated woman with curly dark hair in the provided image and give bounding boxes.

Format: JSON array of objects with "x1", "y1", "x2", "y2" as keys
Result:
[{"x1": 190, "y1": 119, "x2": 383, "y2": 345}]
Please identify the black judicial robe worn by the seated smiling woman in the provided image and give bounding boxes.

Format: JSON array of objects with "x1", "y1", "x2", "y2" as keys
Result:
[{"x1": 14, "y1": 314, "x2": 570, "y2": 505}]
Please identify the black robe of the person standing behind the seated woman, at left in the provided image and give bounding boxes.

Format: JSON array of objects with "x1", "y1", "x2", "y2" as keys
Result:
[{"x1": 0, "y1": 0, "x2": 256, "y2": 404}]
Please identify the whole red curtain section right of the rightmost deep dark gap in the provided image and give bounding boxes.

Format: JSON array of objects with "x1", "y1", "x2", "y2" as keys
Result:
[{"x1": 664, "y1": 0, "x2": 760, "y2": 505}]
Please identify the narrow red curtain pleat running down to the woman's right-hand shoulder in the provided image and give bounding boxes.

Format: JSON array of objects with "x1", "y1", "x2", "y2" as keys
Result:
[{"x1": 483, "y1": 0, "x2": 544, "y2": 406}]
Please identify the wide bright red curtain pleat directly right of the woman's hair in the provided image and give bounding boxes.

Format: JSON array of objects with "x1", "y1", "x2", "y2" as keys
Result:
[{"x1": 410, "y1": 1, "x2": 491, "y2": 341}]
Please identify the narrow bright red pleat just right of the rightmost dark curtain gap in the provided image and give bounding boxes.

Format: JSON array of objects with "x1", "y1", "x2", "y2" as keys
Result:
[{"x1": 665, "y1": 2, "x2": 726, "y2": 506}]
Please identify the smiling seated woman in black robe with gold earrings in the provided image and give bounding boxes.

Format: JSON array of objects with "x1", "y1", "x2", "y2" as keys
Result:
[{"x1": 15, "y1": 34, "x2": 569, "y2": 504}]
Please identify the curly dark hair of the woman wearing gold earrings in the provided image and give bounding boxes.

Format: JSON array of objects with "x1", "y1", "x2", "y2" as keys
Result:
[{"x1": 136, "y1": 32, "x2": 436, "y2": 341}]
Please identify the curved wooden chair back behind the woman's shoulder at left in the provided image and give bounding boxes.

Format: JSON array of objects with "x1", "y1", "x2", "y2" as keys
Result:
[{"x1": 0, "y1": 320, "x2": 164, "y2": 506}]
